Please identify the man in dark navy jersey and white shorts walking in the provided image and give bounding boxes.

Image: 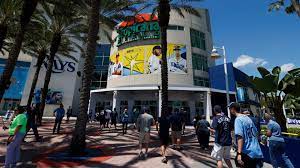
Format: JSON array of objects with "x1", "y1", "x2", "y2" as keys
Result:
[{"x1": 211, "y1": 105, "x2": 232, "y2": 168}]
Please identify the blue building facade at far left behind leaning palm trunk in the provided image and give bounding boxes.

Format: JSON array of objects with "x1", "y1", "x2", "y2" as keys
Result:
[{"x1": 0, "y1": 58, "x2": 30, "y2": 112}]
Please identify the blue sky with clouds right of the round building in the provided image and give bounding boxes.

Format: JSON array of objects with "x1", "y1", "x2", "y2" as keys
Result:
[{"x1": 192, "y1": 0, "x2": 300, "y2": 75}]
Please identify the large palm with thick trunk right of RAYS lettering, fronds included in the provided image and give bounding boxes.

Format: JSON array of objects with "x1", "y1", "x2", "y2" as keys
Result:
[{"x1": 70, "y1": 0, "x2": 144, "y2": 154}]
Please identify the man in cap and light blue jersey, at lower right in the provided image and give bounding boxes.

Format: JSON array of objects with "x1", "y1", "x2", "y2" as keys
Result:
[{"x1": 228, "y1": 103, "x2": 263, "y2": 168}]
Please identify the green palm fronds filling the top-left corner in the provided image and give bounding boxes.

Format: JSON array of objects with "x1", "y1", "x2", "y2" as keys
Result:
[{"x1": 0, "y1": 0, "x2": 22, "y2": 51}]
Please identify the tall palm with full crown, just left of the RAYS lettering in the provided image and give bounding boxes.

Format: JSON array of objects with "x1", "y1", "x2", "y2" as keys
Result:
[{"x1": 36, "y1": 0, "x2": 85, "y2": 121}]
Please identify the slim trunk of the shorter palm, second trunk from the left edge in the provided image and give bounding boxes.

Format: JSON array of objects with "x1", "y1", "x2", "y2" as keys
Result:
[{"x1": 27, "y1": 51, "x2": 46, "y2": 107}]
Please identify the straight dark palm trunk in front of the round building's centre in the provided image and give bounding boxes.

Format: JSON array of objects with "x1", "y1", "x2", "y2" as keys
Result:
[{"x1": 158, "y1": 0, "x2": 170, "y2": 116}]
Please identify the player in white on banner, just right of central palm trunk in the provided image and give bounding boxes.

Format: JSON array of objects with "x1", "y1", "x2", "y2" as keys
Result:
[{"x1": 169, "y1": 46, "x2": 187, "y2": 73}]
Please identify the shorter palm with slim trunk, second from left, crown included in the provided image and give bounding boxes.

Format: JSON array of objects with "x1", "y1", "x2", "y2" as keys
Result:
[{"x1": 22, "y1": 17, "x2": 77, "y2": 107}]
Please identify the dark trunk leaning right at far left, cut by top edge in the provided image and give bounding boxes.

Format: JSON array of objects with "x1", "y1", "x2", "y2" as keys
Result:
[{"x1": 0, "y1": 0, "x2": 38, "y2": 102}]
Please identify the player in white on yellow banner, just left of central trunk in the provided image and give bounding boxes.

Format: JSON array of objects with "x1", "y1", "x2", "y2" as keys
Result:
[{"x1": 148, "y1": 46, "x2": 161, "y2": 74}]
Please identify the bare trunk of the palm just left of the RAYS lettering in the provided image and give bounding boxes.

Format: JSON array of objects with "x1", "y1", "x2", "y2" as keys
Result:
[{"x1": 38, "y1": 33, "x2": 61, "y2": 125}]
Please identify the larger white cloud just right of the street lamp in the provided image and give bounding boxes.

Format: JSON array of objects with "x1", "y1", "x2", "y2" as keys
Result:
[{"x1": 233, "y1": 55, "x2": 268, "y2": 68}]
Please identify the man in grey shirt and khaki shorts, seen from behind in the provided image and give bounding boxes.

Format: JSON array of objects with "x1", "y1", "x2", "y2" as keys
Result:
[{"x1": 136, "y1": 110, "x2": 154, "y2": 158}]
